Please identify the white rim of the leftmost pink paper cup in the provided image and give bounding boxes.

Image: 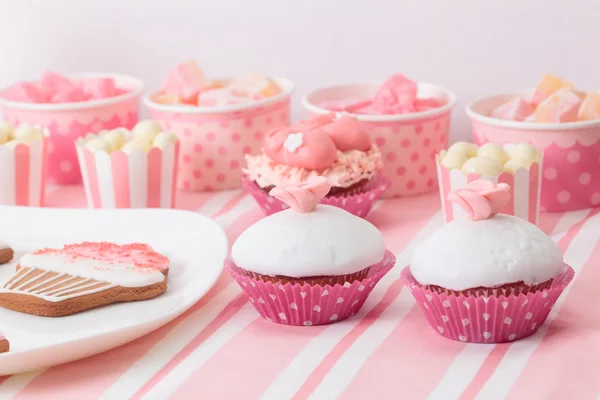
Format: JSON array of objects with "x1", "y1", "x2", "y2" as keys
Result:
[{"x1": 0, "y1": 72, "x2": 144, "y2": 112}]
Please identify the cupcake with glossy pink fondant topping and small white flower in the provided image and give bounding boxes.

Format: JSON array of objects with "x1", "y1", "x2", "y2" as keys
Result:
[{"x1": 243, "y1": 113, "x2": 388, "y2": 216}]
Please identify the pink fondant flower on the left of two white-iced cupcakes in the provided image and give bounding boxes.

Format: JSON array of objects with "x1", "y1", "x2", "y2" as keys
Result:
[{"x1": 269, "y1": 176, "x2": 331, "y2": 213}]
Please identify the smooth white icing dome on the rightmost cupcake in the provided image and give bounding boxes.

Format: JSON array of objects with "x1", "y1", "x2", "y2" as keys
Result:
[{"x1": 410, "y1": 214, "x2": 564, "y2": 290}]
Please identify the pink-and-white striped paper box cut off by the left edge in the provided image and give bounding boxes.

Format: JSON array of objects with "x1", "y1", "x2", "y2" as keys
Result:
[{"x1": 0, "y1": 138, "x2": 47, "y2": 207}]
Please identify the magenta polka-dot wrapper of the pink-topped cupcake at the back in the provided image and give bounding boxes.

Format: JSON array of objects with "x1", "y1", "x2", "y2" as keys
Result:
[{"x1": 242, "y1": 175, "x2": 390, "y2": 218}]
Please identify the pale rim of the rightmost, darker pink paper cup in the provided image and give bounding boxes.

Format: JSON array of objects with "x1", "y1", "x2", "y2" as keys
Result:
[{"x1": 465, "y1": 89, "x2": 600, "y2": 132}]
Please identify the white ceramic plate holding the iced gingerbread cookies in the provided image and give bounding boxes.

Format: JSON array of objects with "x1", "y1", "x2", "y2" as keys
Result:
[{"x1": 0, "y1": 206, "x2": 228, "y2": 375}]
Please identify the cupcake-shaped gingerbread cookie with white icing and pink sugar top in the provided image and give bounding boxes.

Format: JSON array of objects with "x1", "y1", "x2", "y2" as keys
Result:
[{"x1": 0, "y1": 242, "x2": 169, "y2": 317}]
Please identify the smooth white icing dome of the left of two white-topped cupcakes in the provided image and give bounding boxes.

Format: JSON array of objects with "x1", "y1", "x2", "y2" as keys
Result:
[{"x1": 231, "y1": 205, "x2": 385, "y2": 278}]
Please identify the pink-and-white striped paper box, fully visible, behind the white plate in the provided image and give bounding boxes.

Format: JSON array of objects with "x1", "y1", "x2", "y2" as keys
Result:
[{"x1": 77, "y1": 140, "x2": 179, "y2": 208}]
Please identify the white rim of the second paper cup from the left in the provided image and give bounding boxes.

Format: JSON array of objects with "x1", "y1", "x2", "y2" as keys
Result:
[{"x1": 144, "y1": 77, "x2": 295, "y2": 115}]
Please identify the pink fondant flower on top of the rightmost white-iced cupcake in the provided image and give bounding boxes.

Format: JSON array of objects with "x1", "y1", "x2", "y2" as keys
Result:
[{"x1": 448, "y1": 179, "x2": 510, "y2": 221}]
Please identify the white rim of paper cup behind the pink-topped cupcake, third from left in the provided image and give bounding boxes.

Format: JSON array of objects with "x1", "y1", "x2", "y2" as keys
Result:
[{"x1": 302, "y1": 81, "x2": 456, "y2": 122}]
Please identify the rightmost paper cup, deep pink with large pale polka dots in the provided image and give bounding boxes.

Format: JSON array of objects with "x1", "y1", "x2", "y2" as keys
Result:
[{"x1": 467, "y1": 95, "x2": 600, "y2": 211}]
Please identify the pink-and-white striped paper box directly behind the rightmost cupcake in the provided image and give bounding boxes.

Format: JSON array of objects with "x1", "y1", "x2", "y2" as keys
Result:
[{"x1": 436, "y1": 155, "x2": 543, "y2": 225}]
